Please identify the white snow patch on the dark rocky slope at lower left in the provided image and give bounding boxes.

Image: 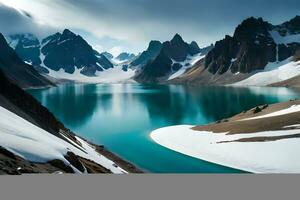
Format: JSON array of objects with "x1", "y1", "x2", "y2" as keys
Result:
[{"x1": 0, "y1": 106, "x2": 126, "y2": 173}]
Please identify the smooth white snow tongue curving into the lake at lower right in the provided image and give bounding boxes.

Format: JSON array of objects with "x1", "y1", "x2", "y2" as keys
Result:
[{"x1": 150, "y1": 125, "x2": 300, "y2": 173}]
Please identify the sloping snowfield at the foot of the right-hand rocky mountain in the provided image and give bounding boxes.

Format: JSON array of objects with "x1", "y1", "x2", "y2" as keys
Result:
[{"x1": 232, "y1": 58, "x2": 300, "y2": 86}]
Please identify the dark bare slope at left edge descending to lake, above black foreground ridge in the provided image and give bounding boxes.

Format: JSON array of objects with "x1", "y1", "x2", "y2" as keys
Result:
[{"x1": 0, "y1": 34, "x2": 53, "y2": 88}]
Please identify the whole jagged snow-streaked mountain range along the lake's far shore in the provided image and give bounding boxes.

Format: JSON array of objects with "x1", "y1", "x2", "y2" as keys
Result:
[{"x1": 2, "y1": 16, "x2": 300, "y2": 85}]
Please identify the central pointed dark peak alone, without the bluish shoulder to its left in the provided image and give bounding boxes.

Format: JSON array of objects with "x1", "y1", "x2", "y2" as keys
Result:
[{"x1": 135, "y1": 34, "x2": 212, "y2": 82}]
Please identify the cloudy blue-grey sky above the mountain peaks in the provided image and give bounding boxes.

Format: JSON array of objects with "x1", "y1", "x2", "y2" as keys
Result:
[{"x1": 0, "y1": 0, "x2": 300, "y2": 54}]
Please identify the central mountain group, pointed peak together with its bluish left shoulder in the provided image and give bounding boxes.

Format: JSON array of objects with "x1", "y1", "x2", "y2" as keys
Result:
[{"x1": 132, "y1": 34, "x2": 212, "y2": 82}]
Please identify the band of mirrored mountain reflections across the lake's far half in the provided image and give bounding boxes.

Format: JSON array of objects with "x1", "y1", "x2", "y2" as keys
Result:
[{"x1": 30, "y1": 84, "x2": 298, "y2": 127}]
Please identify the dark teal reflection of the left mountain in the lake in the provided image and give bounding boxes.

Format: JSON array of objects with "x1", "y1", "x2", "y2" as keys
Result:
[{"x1": 30, "y1": 84, "x2": 98, "y2": 127}]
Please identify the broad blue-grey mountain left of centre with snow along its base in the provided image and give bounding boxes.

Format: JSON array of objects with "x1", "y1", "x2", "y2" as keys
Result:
[{"x1": 6, "y1": 29, "x2": 139, "y2": 83}]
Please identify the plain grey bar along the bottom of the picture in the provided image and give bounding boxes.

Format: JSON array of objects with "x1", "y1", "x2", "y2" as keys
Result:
[{"x1": 0, "y1": 174, "x2": 300, "y2": 200}]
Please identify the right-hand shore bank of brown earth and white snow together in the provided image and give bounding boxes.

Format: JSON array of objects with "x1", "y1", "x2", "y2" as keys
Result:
[{"x1": 150, "y1": 101, "x2": 300, "y2": 173}]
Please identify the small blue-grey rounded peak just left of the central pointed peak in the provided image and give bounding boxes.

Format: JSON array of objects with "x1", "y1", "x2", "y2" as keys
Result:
[{"x1": 130, "y1": 41, "x2": 162, "y2": 67}]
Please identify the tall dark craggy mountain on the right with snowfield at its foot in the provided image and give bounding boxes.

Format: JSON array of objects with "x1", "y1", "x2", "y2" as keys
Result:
[{"x1": 171, "y1": 16, "x2": 300, "y2": 85}]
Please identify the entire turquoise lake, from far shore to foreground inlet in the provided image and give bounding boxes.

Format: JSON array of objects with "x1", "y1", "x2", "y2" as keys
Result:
[{"x1": 29, "y1": 84, "x2": 300, "y2": 173}]
